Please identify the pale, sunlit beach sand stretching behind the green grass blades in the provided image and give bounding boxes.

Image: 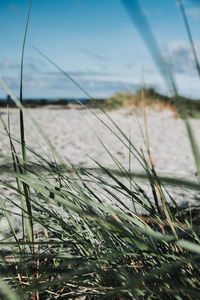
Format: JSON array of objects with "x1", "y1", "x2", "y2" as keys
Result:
[{"x1": 0, "y1": 107, "x2": 200, "y2": 236}]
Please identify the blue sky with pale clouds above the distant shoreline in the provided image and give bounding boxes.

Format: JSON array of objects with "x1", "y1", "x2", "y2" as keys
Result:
[{"x1": 0, "y1": 0, "x2": 200, "y2": 99}]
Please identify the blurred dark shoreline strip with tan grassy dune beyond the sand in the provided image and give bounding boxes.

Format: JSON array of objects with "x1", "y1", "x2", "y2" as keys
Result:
[{"x1": 0, "y1": 88, "x2": 200, "y2": 119}]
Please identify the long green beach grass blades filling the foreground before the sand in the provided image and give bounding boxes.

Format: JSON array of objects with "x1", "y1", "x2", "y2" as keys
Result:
[{"x1": 0, "y1": 1, "x2": 200, "y2": 300}]
